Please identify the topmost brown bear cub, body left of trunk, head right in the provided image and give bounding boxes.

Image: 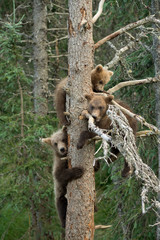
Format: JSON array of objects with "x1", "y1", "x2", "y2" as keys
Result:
[{"x1": 54, "y1": 64, "x2": 113, "y2": 126}]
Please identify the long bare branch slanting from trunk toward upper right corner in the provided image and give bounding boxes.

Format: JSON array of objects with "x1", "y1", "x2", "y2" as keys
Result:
[{"x1": 94, "y1": 15, "x2": 160, "y2": 49}]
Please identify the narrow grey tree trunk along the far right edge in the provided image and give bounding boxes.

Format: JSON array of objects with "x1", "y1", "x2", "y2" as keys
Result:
[{"x1": 152, "y1": 0, "x2": 160, "y2": 240}]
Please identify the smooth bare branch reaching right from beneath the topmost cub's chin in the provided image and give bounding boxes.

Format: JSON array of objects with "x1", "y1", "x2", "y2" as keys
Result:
[{"x1": 107, "y1": 76, "x2": 160, "y2": 94}]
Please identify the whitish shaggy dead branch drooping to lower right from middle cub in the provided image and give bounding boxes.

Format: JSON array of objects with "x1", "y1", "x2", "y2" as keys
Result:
[{"x1": 83, "y1": 105, "x2": 160, "y2": 213}]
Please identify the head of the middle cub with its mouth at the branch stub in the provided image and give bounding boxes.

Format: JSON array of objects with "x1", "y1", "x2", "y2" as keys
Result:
[{"x1": 85, "y1": 93, "x2": 114, "y2": 123}]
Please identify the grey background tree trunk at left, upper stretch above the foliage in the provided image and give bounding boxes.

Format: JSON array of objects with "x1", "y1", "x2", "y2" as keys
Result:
[{"x1": 33, "y1": 0, "x2": 48, "y2": 115}]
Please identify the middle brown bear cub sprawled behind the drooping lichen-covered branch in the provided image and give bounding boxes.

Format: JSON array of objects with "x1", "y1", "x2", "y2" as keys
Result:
[{"x1": 77, "y1": 93, "x2": 137, "y2": 177}]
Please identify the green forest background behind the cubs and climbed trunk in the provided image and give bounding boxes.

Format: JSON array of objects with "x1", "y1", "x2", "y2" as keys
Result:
[{"x1": 0, "y1": 0, "x2": 158, "y2": 240}]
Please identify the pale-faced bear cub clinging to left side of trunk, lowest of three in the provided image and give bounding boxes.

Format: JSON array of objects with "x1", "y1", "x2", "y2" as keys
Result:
[{"x1": 42, "y1": 128, "x2": 84, "y2": 228}]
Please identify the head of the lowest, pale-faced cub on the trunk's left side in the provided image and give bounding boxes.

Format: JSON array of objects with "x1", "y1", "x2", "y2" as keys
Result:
[{"x1": 41, "y1": 128, "x2": 68, "y2": 157}]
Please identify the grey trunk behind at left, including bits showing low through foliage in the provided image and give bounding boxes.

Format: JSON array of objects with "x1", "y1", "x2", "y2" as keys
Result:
[{"x1": 32, "y1": 0, "x2": 48, "y2": 240}]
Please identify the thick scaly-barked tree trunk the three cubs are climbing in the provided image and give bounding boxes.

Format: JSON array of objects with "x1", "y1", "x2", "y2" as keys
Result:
[{"x1": 65, "y1": 0, "x2": 95, "y2": 240}]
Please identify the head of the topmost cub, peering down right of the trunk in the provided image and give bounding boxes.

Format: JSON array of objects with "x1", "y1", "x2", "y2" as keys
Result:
[{"x1": 91, "y1": 64, "x2": 113, "y2": 92}]
